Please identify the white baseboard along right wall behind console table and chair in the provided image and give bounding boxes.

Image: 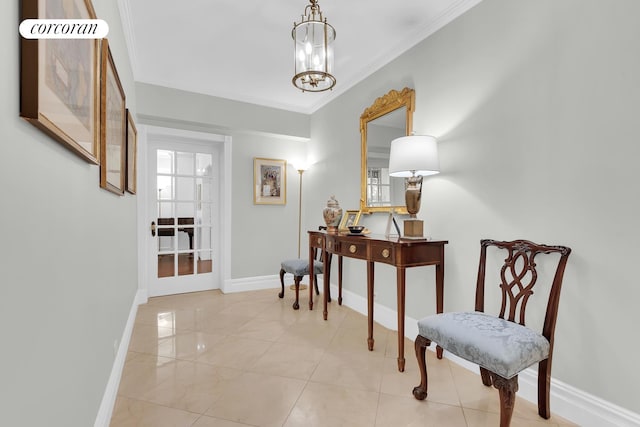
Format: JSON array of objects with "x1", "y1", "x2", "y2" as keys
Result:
[{"x1": 331, "y1": 284, "x2": 640, "y2": 427}]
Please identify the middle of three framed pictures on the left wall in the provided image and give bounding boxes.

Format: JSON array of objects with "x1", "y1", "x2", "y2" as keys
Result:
[{"x1": 100, "y1": 39, "x2": 127, "y2": 195}]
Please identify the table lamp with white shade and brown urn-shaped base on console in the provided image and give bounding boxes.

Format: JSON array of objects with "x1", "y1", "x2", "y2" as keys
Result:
[{"x1": 389, "y1": 135, "x2": 440, "y2": 238}]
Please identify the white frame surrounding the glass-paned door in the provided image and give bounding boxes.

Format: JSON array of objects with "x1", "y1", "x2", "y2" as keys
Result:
[{"x1": 137, "y1": 125, "x2": 232, "y2": 303}]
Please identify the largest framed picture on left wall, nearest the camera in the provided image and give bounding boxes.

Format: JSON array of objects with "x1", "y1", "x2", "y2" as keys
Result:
[{"x1": 20, "y1": 0, "x2": 100, "y2": 164}]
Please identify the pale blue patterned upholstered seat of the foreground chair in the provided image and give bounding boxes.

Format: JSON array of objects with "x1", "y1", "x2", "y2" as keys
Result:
[{"x1": 418, "y1": 312, "x2": 549, "y2": 379}]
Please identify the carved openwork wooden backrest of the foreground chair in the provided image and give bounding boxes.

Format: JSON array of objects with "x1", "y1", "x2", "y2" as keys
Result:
[{"x1": 476, "y1": 239, "x2": 571, "y2": 341}]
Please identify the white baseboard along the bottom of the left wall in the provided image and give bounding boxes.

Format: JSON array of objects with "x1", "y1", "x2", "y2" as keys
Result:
[{"x1": 93, "y1": 290, "x2": 147, "y2": 427}]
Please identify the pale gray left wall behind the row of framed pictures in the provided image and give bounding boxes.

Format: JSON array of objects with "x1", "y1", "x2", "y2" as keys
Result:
[{"x1": 0, "y1": 0, "x2": 137, "y2": 427}]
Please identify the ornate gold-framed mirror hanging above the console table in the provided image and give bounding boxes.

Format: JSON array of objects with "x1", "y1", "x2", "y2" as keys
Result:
[{"x1": 360, "y1": 88, "x2": 416, "y2": 213}]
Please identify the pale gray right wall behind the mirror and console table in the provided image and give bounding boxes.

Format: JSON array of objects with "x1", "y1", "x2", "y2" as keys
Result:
[{"x1": 305, "y1": 0, "x2": 640, "y2": 413}]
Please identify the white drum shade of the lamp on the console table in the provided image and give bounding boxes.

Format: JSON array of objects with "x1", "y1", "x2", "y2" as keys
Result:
[{"x1": 389, "y1": 135, "x2": 440, "y2": 178}]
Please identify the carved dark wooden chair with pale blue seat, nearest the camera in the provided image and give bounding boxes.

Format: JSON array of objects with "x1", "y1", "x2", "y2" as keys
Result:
[{"x1": 413, "y1": 240, "x2": 571, "y2": 427}]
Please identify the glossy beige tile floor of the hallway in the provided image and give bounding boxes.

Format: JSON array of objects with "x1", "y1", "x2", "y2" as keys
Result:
[{"x1": 111, "y1": 290, "x2": 573, "y2": 427}]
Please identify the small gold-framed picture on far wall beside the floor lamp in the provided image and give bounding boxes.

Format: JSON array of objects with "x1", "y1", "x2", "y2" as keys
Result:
[{"x1": 253, "y1": 157, "x2": 287, "y2": 205}]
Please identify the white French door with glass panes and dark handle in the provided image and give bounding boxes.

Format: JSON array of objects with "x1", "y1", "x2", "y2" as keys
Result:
[{"x1": 147, "y1": 138, "x2": 222, "y2": 296}]
